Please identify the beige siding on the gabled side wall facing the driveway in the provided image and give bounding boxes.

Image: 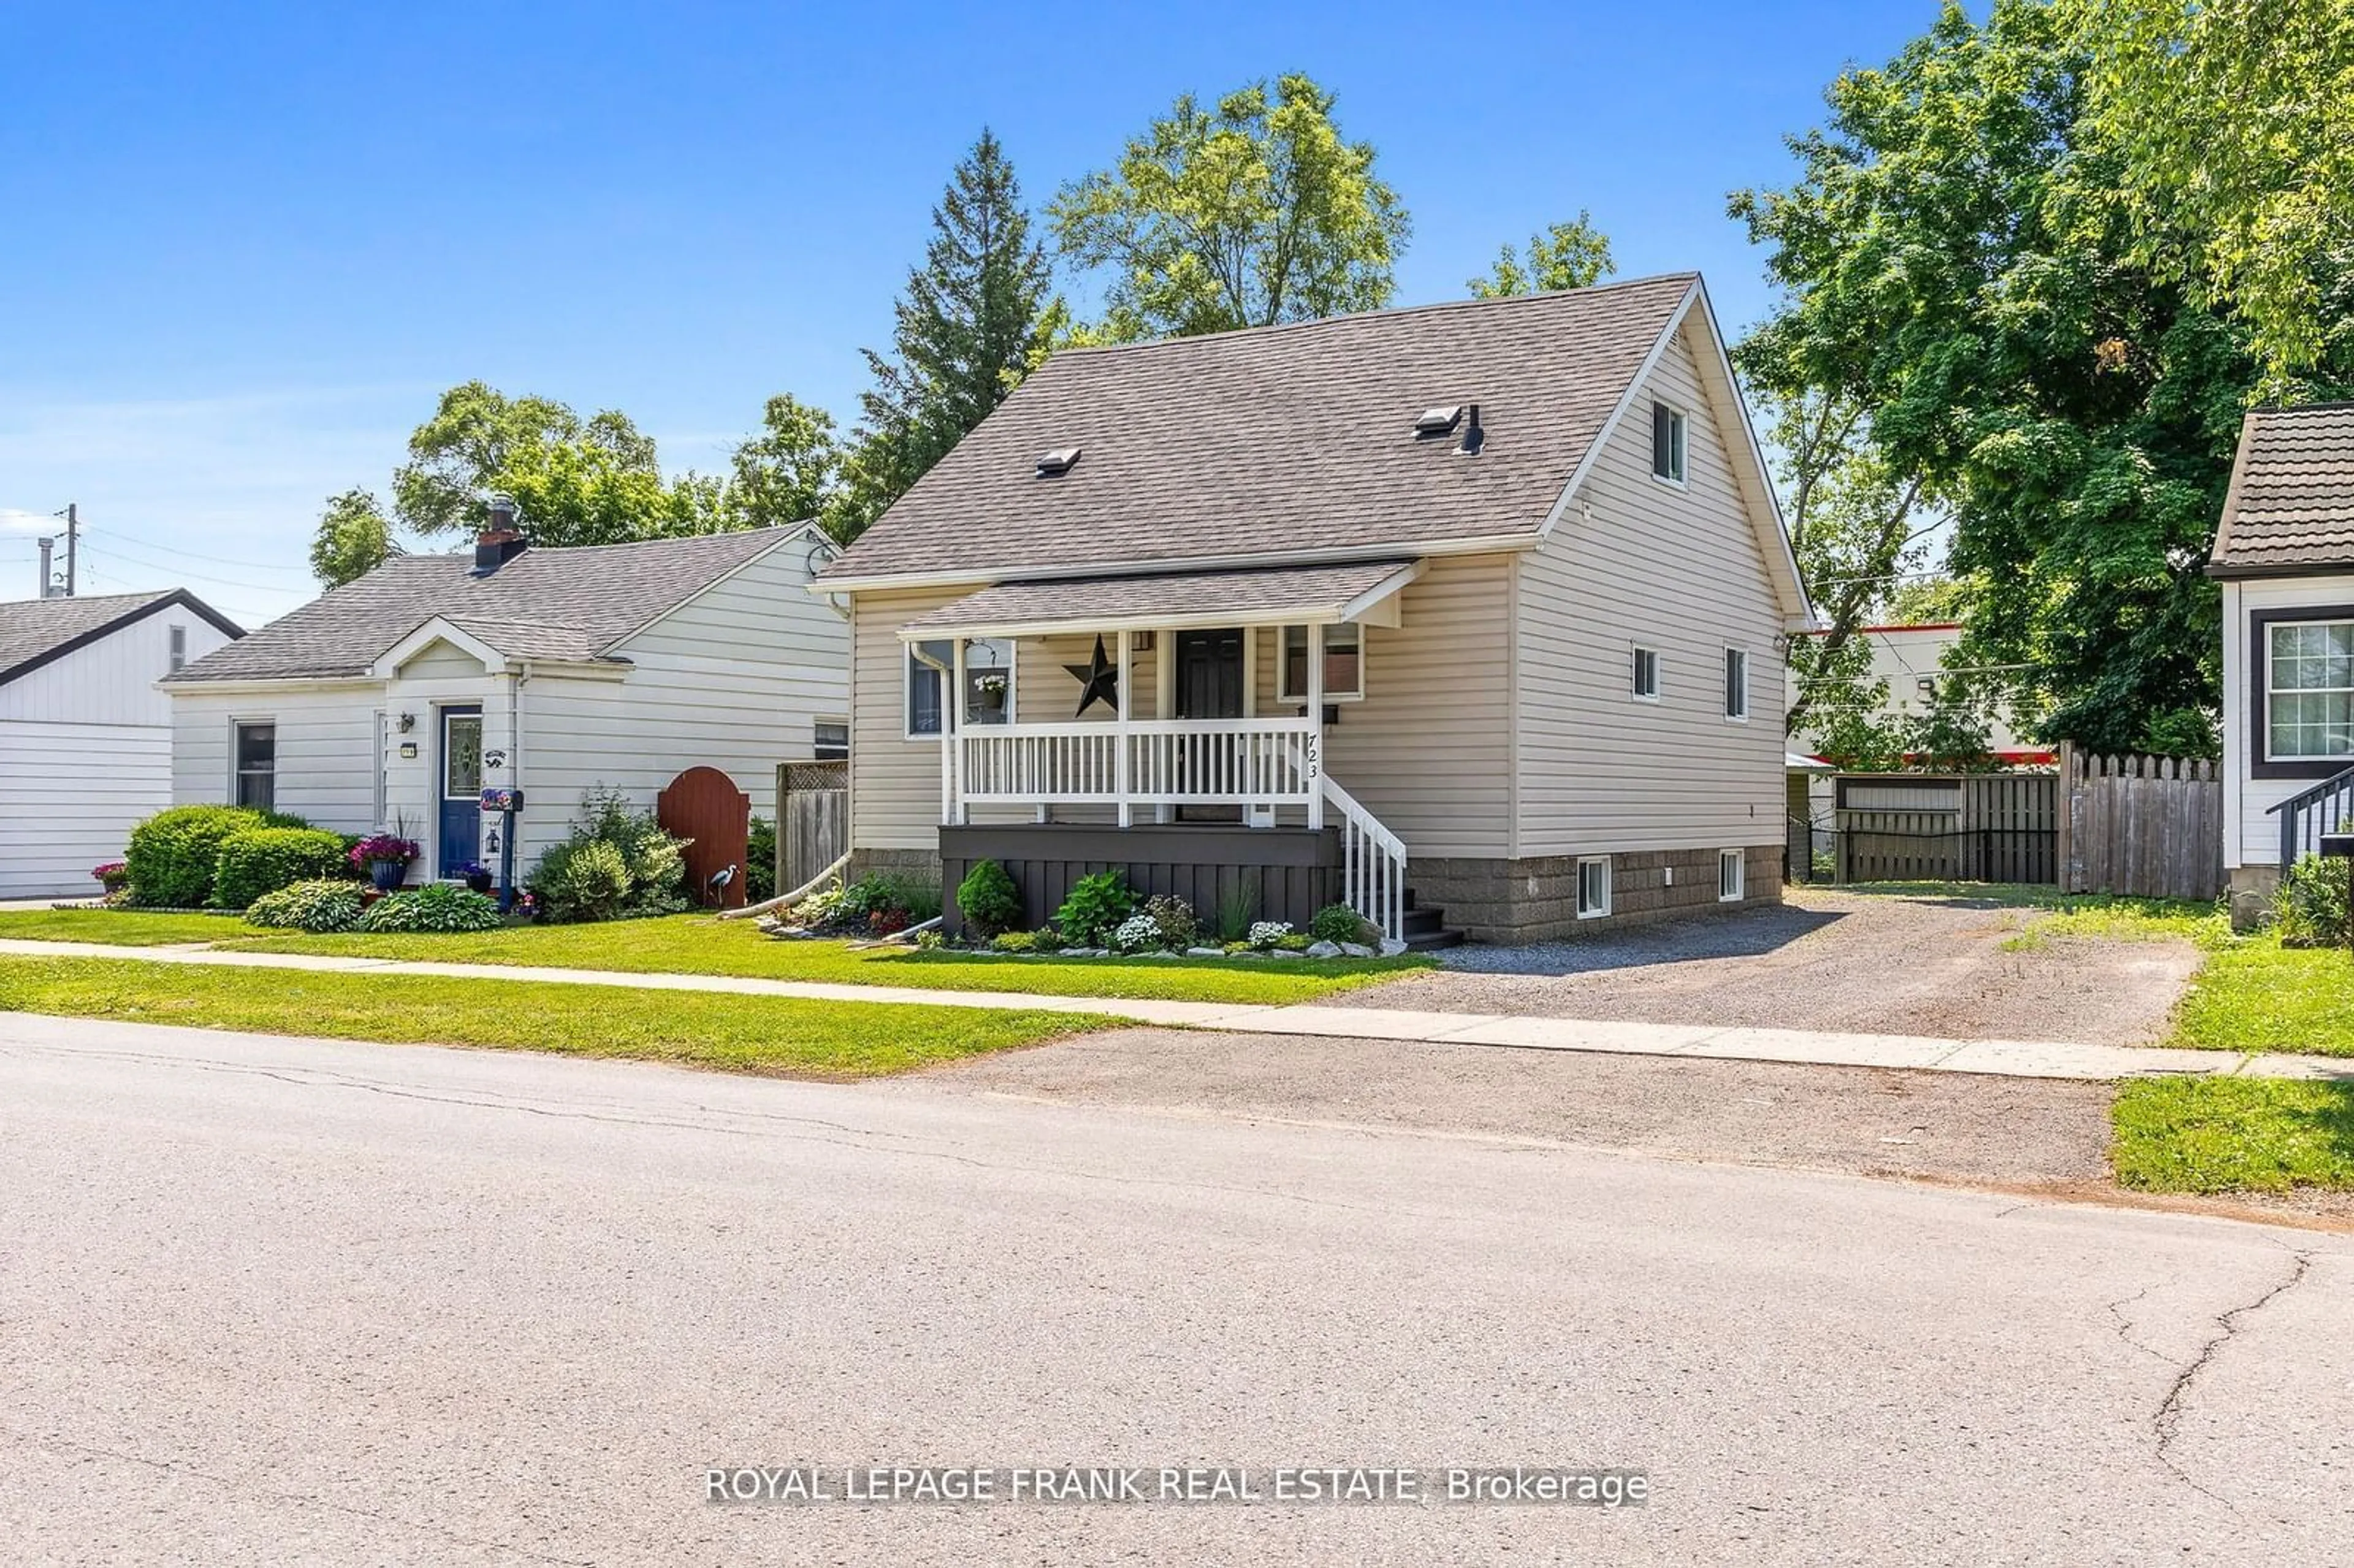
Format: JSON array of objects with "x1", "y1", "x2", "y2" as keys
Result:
[{"x1": 1506, "y1": 327, "x2": 1785, "y2": 857}]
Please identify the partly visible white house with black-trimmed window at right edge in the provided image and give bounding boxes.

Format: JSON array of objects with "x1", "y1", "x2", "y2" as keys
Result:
[{"x1": 2208, "y1": 403, "x2": 2354, "y2": 923}]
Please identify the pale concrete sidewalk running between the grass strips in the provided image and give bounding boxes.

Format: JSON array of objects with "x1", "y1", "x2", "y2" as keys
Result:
[{"x1": 0, "y1": 939, "x2": 2354, "y2": 1081}]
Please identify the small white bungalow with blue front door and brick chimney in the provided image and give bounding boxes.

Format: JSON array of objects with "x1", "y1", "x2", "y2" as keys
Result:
[{"x1": 162, "y1": 513, "x2": 850, "y2": 880}]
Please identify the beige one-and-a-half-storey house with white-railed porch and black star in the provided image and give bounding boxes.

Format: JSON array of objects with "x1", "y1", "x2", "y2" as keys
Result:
[{"x1": 812, "y1": 273, "x2": 1810, "y2": 944}]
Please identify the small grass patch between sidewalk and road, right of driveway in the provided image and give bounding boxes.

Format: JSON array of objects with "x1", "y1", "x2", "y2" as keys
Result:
[{"x1": 2109, "y1": 1078, "x2": 2354, "y2": 1191}]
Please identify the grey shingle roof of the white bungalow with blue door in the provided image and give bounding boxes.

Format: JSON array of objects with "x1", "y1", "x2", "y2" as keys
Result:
[{"x1": 172, "y1": 527, "x2": 798, "y2": 685}]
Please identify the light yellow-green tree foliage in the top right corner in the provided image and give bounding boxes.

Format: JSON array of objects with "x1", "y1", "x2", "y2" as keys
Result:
[{"x1": 2069, "y1": 0, "x2": 2354, "y2": 384}]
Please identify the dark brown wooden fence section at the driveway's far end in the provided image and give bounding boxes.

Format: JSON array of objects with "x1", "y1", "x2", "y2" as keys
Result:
[{"x1": 1832, "y1": 772, "x2": 2060, "y2": 883}]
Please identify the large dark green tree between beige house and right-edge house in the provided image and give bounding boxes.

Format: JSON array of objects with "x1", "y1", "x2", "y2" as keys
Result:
[{"x1": 1732, "y1": 0, "x2": 2335, "y2": 751}]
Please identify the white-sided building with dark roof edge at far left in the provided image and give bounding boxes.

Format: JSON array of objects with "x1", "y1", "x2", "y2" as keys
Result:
[{"x1": 0, "y1": 588, "x2": 243, "y2": 899}]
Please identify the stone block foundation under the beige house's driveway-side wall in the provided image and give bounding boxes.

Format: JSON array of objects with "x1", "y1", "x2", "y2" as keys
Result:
[{"x1": 1405, "y1": 843, "x2": 1782, "y2": 944}]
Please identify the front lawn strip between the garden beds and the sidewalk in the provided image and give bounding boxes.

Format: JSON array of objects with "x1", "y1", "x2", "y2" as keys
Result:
[{"x1": 0, "y1": 909, "x2": 1429, "y2": 1005}]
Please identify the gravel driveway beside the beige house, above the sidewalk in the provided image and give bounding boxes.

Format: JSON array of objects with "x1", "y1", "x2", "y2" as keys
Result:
[{"x1": 1349, "y1": 888, "x2": 2199, "y2": 1045}]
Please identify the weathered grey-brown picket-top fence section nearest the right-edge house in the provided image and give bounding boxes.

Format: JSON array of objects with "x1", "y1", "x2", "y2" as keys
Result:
[{"x1": 2060, "y1": 747, "x2": 2225, "y2": 899}]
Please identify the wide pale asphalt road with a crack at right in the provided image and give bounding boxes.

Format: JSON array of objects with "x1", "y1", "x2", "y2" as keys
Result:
[{"x1": 0, "y1": 1014, "x2": 2354, "y2": 1566}]
